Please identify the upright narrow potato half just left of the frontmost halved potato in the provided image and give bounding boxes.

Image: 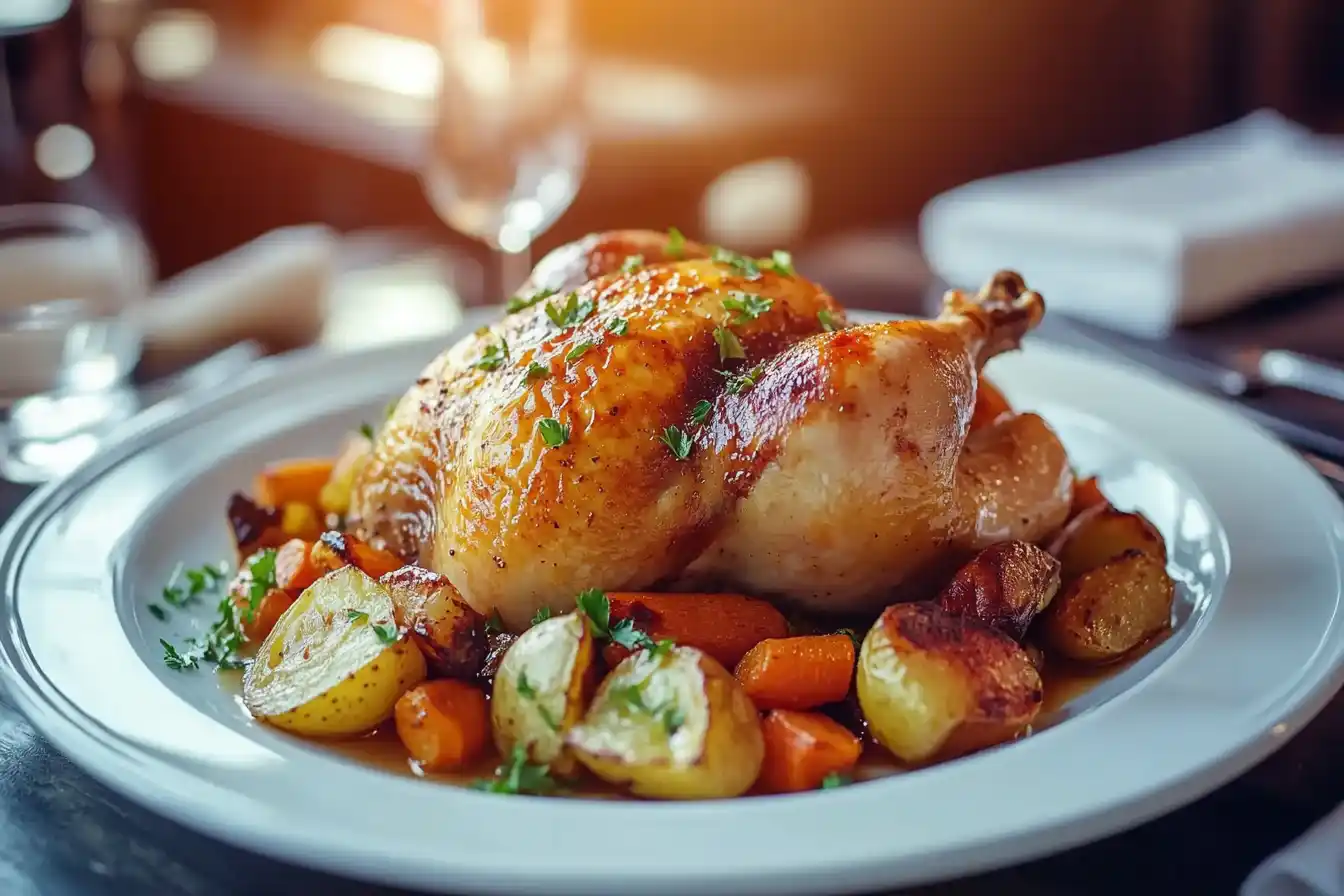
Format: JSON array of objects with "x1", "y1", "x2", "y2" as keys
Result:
[{"x1": 491, "y1": 613, "x2": 598, "y2": 775}]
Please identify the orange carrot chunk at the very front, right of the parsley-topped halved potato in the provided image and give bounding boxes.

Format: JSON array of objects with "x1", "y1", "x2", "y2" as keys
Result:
[{"x1": 758, "y1": 709, "x2": 863, "y2": 793}]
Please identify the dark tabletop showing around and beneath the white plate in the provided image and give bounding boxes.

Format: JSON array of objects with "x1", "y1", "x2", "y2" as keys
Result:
[{"x1": 0, "y1": 275, "x2": 1344, "y2": 896}]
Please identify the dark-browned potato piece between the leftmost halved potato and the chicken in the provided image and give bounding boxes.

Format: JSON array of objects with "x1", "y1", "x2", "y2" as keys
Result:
[{"x1": 379, "y1": 567, "x2": 485, "y2": 678}]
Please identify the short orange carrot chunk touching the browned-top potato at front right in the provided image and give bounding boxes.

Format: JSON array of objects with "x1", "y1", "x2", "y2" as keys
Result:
[{"x1": 734, "y1": 634, "x2": 853, "y2": 709}]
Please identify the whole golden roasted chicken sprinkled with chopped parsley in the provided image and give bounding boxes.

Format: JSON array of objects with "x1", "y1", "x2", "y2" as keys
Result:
[{"x1": 349, "y1": 231, "x2": 1073, "y2": 630}]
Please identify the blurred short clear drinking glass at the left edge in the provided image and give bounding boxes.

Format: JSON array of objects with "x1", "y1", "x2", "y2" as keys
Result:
[{"x1": 0, "y1": 204, "x2": 148, "y2": 482}]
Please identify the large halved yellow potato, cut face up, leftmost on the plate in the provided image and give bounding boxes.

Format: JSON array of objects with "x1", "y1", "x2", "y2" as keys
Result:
[{"x1": 243, "y1": 566, "x2": 425, "y2": 737}]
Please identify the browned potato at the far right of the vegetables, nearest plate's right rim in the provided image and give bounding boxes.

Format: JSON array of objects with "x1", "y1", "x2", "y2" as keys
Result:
[{"x1": 1039, "y1": 548, "x2": 1176, "y2": 662}]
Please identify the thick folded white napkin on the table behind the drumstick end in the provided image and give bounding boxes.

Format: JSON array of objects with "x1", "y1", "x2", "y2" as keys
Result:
[{"x1": 921, "y1": 111, "x2": 1344, "y2": 336}]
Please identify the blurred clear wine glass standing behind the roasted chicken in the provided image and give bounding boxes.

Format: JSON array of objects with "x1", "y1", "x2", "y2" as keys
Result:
[{"x1": 422, "y1": 0, "x2": 587, "y2": 301}]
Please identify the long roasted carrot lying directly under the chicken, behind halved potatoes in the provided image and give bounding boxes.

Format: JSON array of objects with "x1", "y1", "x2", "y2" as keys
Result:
[{"x1": 602, "y1": 592, "x2": 789, "y2": 669}]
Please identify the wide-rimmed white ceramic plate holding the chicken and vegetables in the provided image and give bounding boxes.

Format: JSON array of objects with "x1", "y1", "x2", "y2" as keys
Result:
[{"x1": 0, "y1": 310, "x2": 1344, "y2": 896}]
